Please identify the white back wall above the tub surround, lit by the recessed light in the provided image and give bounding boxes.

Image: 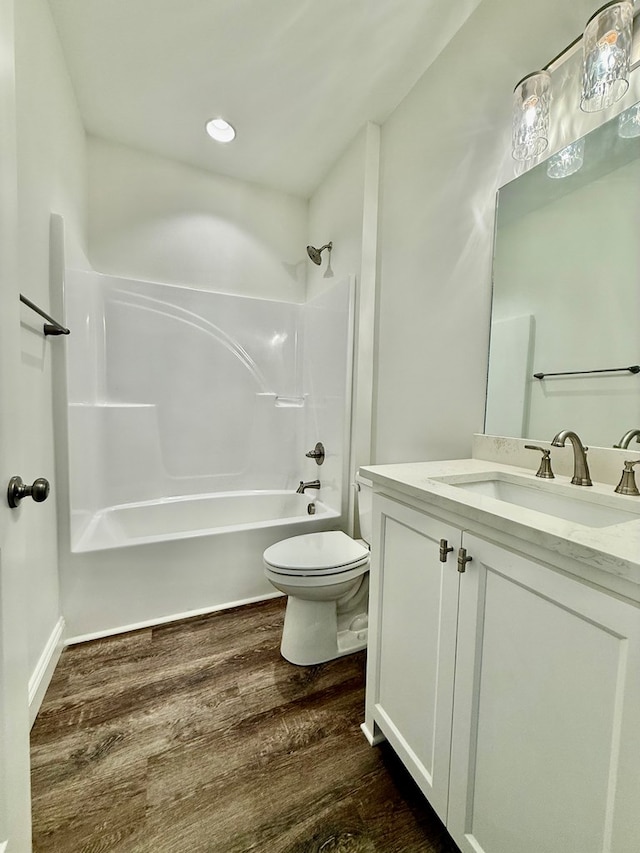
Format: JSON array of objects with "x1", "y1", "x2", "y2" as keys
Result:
[{"x1": 89, "y1": 137, "x2": 307, "y2": 302}]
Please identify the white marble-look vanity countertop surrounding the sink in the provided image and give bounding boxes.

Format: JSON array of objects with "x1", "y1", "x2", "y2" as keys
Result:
[{"x1": 360, "y1": 459, "x2": 640, "y2": 600}]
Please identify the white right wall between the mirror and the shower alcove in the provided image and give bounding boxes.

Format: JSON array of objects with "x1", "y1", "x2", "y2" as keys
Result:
[{"x1": 373, "y1": 0, "x2": 593, "y2": 463}]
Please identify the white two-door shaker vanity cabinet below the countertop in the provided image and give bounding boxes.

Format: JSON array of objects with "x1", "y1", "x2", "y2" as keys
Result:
[{"x1": 365, "y1": 486, "x2": 640, "y2": 853}]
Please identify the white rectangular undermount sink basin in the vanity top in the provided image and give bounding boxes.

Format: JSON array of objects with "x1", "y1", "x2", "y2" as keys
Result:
[{"x1": 449, "y1": 473, "x2": 640, "y2": 527}]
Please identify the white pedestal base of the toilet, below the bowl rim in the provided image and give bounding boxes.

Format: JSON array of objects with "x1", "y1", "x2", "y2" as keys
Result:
[{"x1": 280, "y1": 575, "x2": 368, "y2": 666}]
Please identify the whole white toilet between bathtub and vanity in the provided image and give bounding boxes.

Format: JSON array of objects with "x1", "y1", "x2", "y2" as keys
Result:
[{"x1": 263, "y1": 475, "x2": 373, "y2": 666}]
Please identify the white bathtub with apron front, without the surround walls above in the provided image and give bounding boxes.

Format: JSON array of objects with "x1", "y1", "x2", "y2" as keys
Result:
[{"x1": 60, "y1": 491, "x2": 341, "y2": 643}]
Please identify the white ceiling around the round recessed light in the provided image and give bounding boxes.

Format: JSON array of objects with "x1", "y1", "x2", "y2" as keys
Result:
[{"x1": 49, "y1": 0, "x2": 480, "y2": 198}]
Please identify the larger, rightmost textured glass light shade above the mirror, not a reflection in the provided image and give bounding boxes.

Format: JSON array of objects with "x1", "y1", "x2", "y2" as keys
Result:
[{"x1": 580, "y1": 0, "x2": 633, "y2": 113}]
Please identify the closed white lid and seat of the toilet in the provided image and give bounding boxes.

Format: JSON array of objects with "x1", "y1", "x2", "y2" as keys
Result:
[{"x1": 263, "y1": 530, "x2": 369, "y2": 573}]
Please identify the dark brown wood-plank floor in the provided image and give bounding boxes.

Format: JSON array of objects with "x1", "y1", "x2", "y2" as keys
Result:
[{"x1": 31, "y1": 599, "x2": 457, "y2": 853}]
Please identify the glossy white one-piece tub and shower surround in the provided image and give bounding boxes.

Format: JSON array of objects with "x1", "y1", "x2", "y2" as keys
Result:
[{"x1": 56, "y1": 240, "x2": 354, "y2": 639}]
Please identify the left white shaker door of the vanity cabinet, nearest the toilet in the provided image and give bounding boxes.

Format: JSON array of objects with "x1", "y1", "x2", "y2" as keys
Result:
[{"x1": 368, "y1": 496, "x2": 460, "y2": 820}]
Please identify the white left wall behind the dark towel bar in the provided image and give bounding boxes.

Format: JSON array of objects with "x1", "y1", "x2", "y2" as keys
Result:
[{"x1": 15, "y1": 0, "x2": 86, "y2": 684}]
